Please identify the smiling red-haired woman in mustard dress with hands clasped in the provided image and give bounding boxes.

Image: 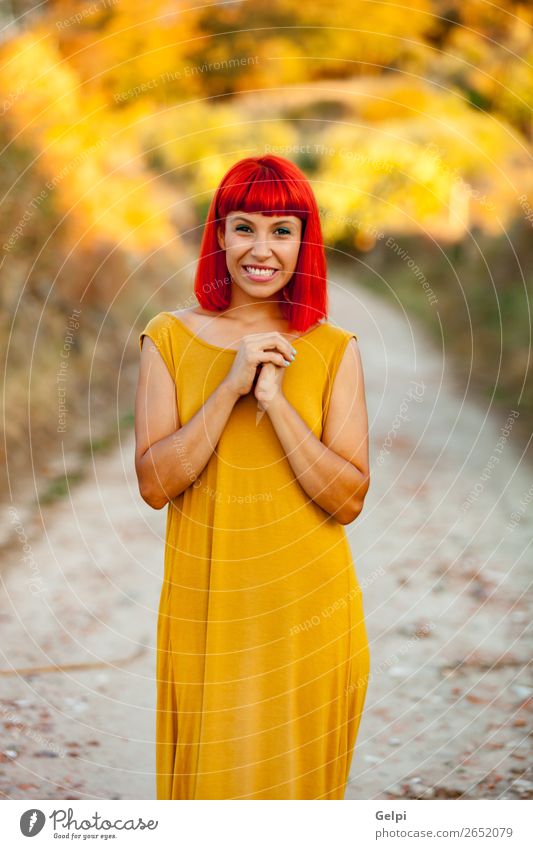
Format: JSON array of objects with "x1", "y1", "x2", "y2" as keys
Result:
[{"x1": 135, "y1": 156, "x2": 369, "y2": 799}]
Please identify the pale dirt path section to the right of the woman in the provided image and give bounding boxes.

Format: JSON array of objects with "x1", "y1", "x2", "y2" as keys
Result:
[{"x1": 334, "y1": 274, "x2": 533, "y2": 799}]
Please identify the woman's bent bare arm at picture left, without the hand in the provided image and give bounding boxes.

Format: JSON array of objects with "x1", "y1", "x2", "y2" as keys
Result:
[{"x1": 135, "y1": 336, "x2": 239, "y2": 510}]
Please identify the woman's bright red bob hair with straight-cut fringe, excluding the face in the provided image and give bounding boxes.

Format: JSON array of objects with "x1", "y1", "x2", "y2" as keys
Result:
[{"x1": 194, "y1": 155, "x2": 328, "y2": 333}]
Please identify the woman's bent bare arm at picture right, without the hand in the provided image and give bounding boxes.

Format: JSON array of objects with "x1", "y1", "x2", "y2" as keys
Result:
[{"x1": 260, "y1": 338, "x2": 370, "y2": 525}]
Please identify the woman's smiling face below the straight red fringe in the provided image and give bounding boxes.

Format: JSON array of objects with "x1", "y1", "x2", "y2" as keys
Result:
[{"x1": 214, "y1": 211, "x2": 302, "y2": 298}]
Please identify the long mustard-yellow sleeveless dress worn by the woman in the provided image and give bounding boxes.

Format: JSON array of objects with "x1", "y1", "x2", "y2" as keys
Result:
[{"x1": 139, "y1": 312, "x2": 370, "y2": 799}]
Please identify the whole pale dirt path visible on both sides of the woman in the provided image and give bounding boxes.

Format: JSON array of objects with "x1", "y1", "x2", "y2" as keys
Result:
[{"x1": 0, "y1": 275, "x2": 533, "y2": 799}]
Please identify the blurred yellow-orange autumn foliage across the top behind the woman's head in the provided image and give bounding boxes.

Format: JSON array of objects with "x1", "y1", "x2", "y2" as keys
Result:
[{"x1": 0, "y1": 0, "x2": 533, "y2": 250}]
